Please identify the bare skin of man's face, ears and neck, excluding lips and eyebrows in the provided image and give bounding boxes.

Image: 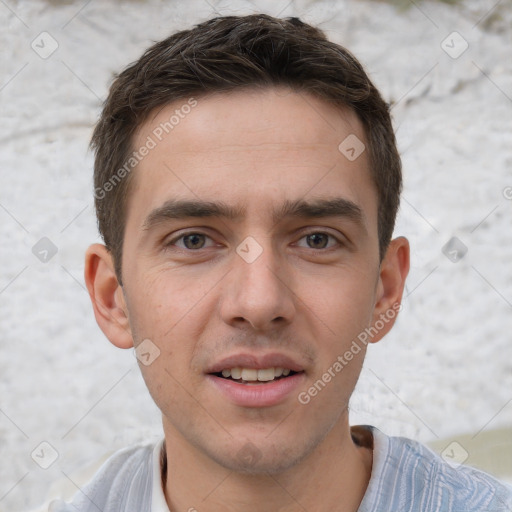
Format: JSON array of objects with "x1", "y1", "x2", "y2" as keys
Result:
[{"x1": 85, "y1": 89, "x2": 409, "y2": 512}]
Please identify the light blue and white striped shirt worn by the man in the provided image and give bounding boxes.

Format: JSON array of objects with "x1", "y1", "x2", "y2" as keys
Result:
[{"x1": 49, "y1": 426, "x2": 512, "y2": 512}]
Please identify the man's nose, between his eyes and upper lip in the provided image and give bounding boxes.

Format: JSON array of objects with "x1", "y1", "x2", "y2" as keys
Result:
[{"x1": 221, "y1": 242, "x2": 295, "y2": 332}]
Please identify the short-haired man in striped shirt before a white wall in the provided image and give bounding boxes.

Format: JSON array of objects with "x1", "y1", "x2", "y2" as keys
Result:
[{"x1": 52, "y1": 15, "x2": 512, "y2": 512}]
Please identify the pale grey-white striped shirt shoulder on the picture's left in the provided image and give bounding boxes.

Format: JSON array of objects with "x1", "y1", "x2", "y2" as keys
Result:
[{"x1": 48, "y1": 443, "x2": 158, "y2": 512}]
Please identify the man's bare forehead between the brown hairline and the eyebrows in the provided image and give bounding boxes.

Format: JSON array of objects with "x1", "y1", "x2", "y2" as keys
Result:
[{"x1": 128, "y1": 88, "x2": 377, "y2": 226}]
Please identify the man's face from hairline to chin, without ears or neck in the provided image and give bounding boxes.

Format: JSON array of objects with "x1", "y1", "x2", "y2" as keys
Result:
[{"x1": 100, "y1": 89, "x2": 400, "y2": 472}]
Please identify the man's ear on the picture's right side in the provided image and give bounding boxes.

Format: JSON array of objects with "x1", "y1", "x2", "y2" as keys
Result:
[{"x1": 369, "y1": 237, "x2": 410, "y2": 343}]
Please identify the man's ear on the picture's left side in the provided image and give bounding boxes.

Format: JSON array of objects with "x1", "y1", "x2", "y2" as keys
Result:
[{"x1": 84, "y1": 244, "x2": 133, "y2": 348}]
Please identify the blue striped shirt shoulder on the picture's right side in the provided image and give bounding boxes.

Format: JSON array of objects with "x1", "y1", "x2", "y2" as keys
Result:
[{"x1": 360, "y1": 428, "x2": 512, "y2": 512}]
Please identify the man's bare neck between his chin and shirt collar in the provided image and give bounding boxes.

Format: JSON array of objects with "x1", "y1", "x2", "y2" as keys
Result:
[{"x1": 164, "y1": 422, "x2": 372, "y2": 512}]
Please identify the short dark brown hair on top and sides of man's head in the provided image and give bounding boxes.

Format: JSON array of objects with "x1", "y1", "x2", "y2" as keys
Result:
[{"x1": 91, "y1": 14, "x2": 402, "y2": 282}]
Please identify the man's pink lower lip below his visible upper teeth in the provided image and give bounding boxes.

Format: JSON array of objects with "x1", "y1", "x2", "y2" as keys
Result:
[{"x1": 207, "y1": 373, "x2": 304, "y2": 407}]
